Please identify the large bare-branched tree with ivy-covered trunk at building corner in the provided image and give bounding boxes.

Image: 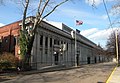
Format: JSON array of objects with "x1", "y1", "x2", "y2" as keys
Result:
[{"x1": 20, "y1": 0, "x2": 69, "y2": 67}]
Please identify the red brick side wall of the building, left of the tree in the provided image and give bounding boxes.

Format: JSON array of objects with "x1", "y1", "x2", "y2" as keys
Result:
[{"x1": 0, "y1": 21, "x2": 21, "y2": 55}]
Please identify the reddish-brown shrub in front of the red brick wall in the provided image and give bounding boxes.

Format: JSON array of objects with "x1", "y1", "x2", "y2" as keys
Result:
[{"x1": 0, "y1": 53, "x2": 17, "y2": 70}]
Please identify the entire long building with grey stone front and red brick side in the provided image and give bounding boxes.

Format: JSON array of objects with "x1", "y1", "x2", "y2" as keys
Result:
[{"x1": 0, "y1": 17, "x2": 109, "y2": 69}]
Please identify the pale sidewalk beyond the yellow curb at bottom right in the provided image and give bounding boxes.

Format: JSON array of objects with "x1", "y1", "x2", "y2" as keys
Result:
[{"x1": 106, "y1": 66, "x2": 120, "y2": 83}]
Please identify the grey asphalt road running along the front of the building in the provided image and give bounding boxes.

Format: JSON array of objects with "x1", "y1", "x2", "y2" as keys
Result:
[{"x1": 0, "y1": 62, "x2": 116, "y2": 83}]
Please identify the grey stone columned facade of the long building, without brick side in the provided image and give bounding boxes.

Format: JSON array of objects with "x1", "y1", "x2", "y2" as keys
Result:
[{"x1": 31, "y1": 21, "x2": 108, "y2": 69}]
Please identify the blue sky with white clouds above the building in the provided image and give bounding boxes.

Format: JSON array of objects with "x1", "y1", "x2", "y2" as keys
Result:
[{"x1": 0, "y1": 0, "x2": 119, "y2": 47}]
